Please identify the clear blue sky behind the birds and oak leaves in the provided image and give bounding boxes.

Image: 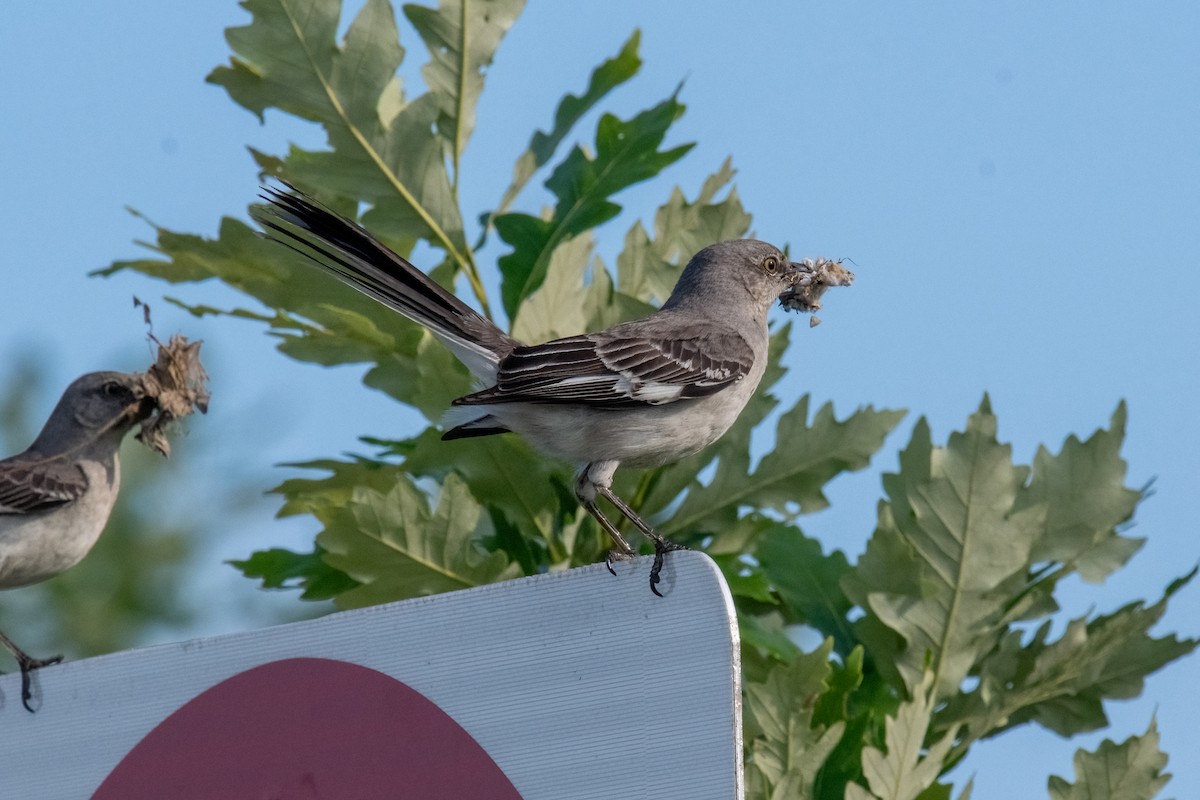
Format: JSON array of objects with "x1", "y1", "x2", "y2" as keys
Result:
[{"x1": 0, "y1": 0, "x2": 1200, "y2": 800}]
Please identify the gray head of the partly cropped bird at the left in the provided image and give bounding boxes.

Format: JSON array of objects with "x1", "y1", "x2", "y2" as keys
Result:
[{"x1": 30, "y1": 372, "x2": 155, "y2": 455}]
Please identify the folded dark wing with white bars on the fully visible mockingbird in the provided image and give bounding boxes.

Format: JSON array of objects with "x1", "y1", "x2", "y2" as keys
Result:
[{"x1": 455, "y1": 325, "x2": 754, "y2": 407}]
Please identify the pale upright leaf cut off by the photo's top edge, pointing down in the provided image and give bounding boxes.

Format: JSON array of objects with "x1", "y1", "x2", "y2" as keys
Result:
[{"x1": 404, "y1": 0, "x2": 524, "y2": 181}]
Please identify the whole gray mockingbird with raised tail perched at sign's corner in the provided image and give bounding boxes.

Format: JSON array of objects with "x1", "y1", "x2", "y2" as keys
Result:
[{"x1": 251, "y1": 190, "x2": 811, "y2": 596}]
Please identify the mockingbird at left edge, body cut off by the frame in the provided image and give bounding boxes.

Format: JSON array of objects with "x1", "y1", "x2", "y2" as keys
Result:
[{"x1": 0, "y1": 372, "x2": 155, "y2": 711}]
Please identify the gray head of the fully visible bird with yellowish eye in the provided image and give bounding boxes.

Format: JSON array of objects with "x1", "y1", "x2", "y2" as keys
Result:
[{"x1": 662, "y1": 239, "x2": 810, "y2": 318}]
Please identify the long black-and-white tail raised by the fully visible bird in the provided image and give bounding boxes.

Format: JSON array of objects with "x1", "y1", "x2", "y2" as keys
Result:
[{"x1": 250, "y1": 188, "x2": 517, "y2": 383}]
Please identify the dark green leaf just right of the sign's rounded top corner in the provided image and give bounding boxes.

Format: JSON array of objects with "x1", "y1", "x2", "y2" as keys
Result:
[{"x1": 754, "y1": 524, "x2": 858, "y2": 656}]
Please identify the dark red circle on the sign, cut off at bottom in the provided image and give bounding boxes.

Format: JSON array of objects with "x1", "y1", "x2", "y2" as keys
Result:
[{"x1": 92, "y1": 658, "x2": 521, "y2": 800}]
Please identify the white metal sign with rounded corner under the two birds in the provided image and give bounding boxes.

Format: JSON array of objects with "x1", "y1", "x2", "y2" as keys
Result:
[{"x1": 0, "y1": 552, "x2": 742, "y2": 800}]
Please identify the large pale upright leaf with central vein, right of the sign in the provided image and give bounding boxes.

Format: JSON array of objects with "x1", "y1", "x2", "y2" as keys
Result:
[{"x1": 847, "y1": 397, "x2": 1042, "y2": 697}]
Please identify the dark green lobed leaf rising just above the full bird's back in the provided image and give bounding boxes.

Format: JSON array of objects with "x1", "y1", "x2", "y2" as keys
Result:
[{"x1": 494, "y1": 95, "x2": 692, "y2": 317}]
